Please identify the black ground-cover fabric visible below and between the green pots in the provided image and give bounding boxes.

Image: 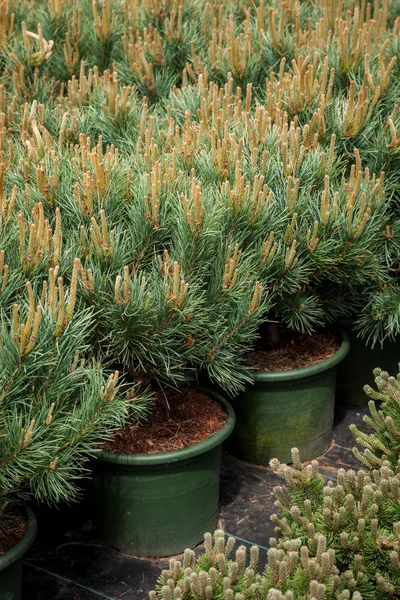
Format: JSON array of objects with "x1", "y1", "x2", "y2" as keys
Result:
[{"x1": 23, "y1": 406, "x2": 368, "y2": 600}]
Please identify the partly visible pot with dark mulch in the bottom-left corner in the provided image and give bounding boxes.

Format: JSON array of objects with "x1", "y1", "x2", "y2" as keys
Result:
[{"x1": 0, "y1": 507, "x2": 36, "y2": 600}]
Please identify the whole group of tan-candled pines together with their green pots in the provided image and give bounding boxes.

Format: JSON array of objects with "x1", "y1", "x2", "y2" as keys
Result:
[{"x1": 0, "y1": 0, "x2": 400, "y2": 600}]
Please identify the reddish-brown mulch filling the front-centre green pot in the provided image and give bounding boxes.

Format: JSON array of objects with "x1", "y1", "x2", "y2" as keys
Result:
[{"x1": 105, "y1": 388, "x2": 227, "y2": 454}]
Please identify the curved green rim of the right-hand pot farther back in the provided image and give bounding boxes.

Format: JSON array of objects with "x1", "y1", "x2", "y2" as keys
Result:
[{"x1": 250, "y1": 328, "x2": 350, "y2": 384}]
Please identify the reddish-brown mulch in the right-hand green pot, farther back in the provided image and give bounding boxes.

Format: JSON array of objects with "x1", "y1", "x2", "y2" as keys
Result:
[{"x1": 245, "y1": 329, "x2": 340, "y2": 372}]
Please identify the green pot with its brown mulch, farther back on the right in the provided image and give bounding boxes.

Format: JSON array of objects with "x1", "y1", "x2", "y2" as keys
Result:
[{"x1": 228, "y1": 330, "x2": 349, "y2": 465}]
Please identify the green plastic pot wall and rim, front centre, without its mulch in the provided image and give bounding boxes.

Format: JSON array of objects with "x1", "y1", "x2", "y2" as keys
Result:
[{"x1": 94, "y1": 388, "x2": 235, "y2": 557}]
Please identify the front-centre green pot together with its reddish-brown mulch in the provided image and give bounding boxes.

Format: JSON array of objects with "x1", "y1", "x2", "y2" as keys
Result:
[{"x1": 94, "y1": 388, "x2": 235, "y2": 557}]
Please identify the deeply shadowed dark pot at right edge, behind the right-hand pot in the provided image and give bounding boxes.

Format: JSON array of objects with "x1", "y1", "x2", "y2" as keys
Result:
[{"x1": 336, "y1": 320, "x2": 400, "y2": 406}]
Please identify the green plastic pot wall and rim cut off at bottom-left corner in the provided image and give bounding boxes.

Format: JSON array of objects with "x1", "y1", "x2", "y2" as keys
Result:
[{"x1": 0, "y1": 507, "x2": 37, "y2": 600}]
